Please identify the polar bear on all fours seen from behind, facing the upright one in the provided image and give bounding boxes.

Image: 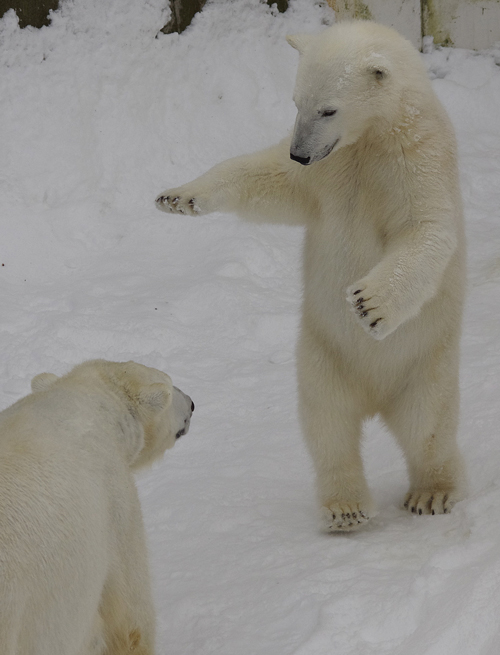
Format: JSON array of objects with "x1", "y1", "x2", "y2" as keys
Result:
[{"x1": 0, "y1": 360, "x2": 194, "y2": 655}]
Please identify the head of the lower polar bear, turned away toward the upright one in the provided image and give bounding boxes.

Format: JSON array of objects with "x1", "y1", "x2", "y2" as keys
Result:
[{"x1": 31, "y1": 360, "x2": 194, "y2": 469}]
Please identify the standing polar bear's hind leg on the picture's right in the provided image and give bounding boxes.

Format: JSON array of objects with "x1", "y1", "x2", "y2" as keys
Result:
[{"x1": 382, "y1": 353, "x2": 466, "y2": 514}]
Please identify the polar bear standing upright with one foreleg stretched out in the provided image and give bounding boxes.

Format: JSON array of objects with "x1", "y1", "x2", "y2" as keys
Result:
[{"x1": 156, "y1": 22, "x2": 465, "y2": 531}]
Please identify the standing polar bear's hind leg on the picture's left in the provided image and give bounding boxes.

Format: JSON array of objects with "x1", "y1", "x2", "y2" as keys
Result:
[{"x1": 298, "y1": 327, "x2": 373, "y2": 532}]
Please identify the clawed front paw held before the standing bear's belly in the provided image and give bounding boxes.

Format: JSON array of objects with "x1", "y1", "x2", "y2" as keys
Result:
[{"x1": 346, "y1": 280, "x2": 399, "y2": 341}]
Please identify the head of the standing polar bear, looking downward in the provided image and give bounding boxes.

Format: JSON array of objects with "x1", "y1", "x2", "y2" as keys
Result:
[{"x1": 287, "y1": 21, "x2": 429, "y2": 165}]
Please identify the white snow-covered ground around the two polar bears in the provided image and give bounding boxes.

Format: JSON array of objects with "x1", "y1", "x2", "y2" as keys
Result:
[{"x1": 0, "y1": 0, "x2": 500, "y2": 655}]
